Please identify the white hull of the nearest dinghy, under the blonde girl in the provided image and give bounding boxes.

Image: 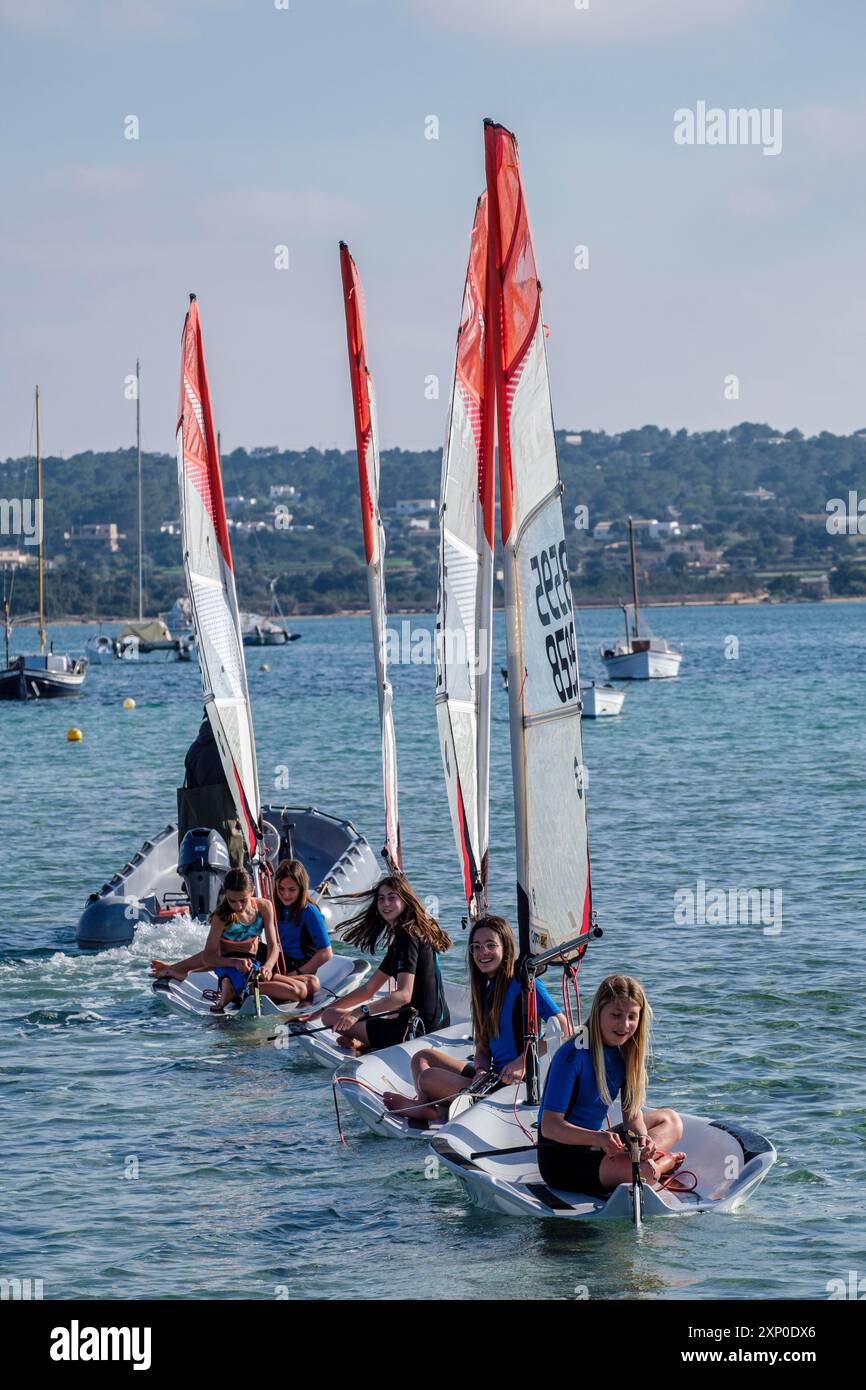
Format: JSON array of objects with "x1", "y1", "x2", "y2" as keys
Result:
[{"x1": 431, "y1": 1087, "x2": 777, "y2": 1222}]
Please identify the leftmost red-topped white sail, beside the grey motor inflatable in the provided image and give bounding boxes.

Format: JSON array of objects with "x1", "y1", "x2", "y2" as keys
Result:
[{"x1": 177, "y1": 295, "x2": 261, "y2": 858}]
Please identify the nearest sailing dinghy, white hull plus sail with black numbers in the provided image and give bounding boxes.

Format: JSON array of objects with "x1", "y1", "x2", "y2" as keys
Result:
[{"x1": 431, "y1": 121, "x2": 776, "y2": 1225}]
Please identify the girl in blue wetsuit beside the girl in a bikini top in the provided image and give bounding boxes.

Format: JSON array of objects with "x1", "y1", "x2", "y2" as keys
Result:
[{"x1": 259, "y1": 859, "x2": 334, "y2": 1004}]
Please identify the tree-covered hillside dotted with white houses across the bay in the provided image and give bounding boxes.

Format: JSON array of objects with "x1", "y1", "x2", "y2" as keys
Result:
[{"x1": 0, "y1": 423, "x2": 866, "y2": 619}]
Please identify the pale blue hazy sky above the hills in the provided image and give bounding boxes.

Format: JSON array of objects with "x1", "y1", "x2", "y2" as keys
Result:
[{"x1": 0, "y1": 0, "x2": 866, "y2": 457}]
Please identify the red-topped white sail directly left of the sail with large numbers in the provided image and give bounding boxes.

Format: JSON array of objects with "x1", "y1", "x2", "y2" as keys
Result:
[{"x1": 436, "y1": 193, "x2": 495, "y2": 912}]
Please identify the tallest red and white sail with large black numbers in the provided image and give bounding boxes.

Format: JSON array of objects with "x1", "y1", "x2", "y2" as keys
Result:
[{"x1": 484, "y1": 121, "x2": 592, "y2": 956}]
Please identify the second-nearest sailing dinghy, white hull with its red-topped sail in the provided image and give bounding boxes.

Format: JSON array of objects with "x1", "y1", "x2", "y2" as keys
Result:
[{"x1": 333, "y1": 195, "x2": 493, "y2": 1117}]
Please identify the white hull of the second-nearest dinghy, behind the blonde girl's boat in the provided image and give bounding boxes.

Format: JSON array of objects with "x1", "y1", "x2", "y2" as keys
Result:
[{"x1": 334, "y1": 1019, "x2": 562, "y2": 1138}]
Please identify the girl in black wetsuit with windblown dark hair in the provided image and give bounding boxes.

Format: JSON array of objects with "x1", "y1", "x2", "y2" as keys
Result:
[{"x1": 306, "y1": 874, "x2": 452, "y2": 1052}]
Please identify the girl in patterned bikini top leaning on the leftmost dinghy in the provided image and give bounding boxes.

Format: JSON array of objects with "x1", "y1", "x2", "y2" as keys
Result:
[{"x1": 150, "y1": 869, "x2": 279, "y2": 1013}]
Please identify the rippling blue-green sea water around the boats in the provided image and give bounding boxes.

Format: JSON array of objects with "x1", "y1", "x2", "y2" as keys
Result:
[{"x1": 0, "y1": 603, "x2": 866, "y2": 1298}]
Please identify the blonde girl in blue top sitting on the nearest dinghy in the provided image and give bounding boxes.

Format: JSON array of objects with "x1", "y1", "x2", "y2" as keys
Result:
[{"x1": 538, "y1": 974, "x2": 685, "y2": 1197}]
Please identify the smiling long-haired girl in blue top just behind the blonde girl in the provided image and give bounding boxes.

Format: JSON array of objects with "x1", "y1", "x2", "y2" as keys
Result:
[{"x1": 382, "y1": 913, "x2": 566, "y2": 1120}]
